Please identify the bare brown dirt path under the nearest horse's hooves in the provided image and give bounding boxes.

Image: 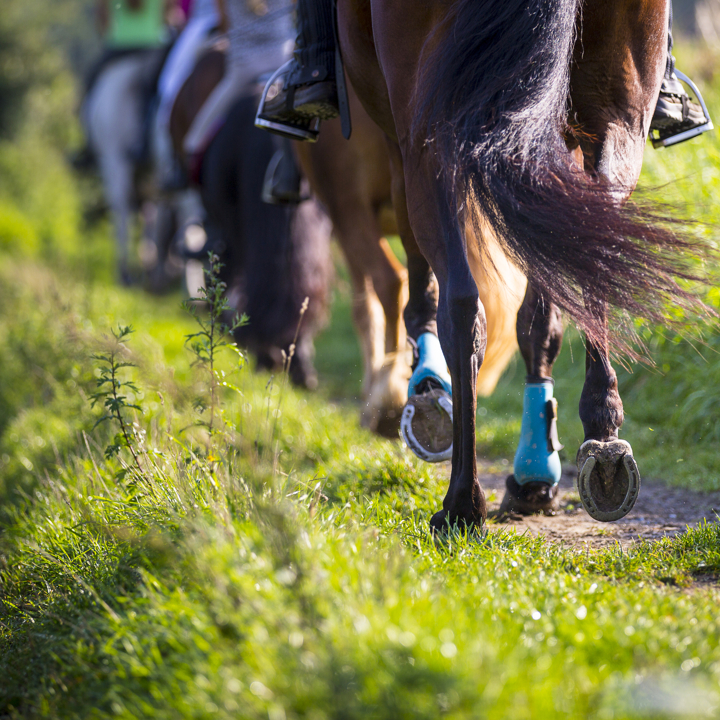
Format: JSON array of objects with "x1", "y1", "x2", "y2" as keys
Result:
[{"x1": 479, "y1": 466, "x2": 720, "y2": 548}]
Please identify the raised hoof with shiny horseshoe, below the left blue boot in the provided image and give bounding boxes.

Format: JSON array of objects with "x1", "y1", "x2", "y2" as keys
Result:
[{"x1": 400, "y1": 389, "x2": 453, "y2": 462}]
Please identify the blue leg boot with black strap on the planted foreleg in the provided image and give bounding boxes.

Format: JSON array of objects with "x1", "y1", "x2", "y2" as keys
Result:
[{"x1": 513, "y1": 378, "x2": 562, "y2": 486}]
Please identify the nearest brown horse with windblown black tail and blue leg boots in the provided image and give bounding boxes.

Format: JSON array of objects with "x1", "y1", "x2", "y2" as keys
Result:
[{"x1": 337, "y1": 0, "x2": 698, "y2": 532}]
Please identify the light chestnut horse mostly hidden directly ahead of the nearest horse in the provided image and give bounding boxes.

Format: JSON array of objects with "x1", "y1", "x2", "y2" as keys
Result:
[{"x1": 295, "y1": 86, "x2": 526, "y2": 438}]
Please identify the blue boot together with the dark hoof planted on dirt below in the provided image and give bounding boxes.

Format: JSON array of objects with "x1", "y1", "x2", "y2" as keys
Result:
[{"x1": 500, "y1": 378, "x2": 562, "y2": 515}]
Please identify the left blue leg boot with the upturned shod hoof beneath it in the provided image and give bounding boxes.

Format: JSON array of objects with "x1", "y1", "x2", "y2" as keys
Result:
[{"x1": 400, "y1": 333, "x2": 453, "y2": 462}]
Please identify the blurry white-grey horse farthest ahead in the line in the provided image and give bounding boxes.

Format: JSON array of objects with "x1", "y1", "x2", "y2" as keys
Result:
[{"x1": 83, "y1": 49, "x2": 166, "y2": 284}]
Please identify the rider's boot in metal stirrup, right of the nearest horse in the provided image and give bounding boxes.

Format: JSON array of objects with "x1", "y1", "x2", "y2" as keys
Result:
[{"x1": 650, "y1": 5, "x2": 713, "y2": 147}]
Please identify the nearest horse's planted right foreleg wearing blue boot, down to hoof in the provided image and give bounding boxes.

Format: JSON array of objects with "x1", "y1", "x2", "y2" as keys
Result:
[{"x1": 500, "y1": 284, "x2": 563, "y2": 515}]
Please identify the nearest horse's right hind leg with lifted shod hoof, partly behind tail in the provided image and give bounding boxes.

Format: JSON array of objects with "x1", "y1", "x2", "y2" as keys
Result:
[{"x1": 571, "y1": 0, "x2": 669, "y2": 521}]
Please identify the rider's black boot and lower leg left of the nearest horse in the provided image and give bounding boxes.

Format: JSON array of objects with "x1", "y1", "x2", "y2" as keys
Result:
[{"x1": 258, "y1": 0, "x2": 340, "y2": 135}]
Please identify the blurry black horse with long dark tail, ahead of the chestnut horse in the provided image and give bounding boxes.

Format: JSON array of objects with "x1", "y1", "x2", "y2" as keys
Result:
[{"x1": 170, "y1": 46, "x2": 332, "y2": 389}]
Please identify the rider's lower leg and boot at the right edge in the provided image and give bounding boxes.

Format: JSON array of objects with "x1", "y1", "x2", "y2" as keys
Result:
[{"x1": 650, "y1": 0, "x2": 710, "y2": 145}]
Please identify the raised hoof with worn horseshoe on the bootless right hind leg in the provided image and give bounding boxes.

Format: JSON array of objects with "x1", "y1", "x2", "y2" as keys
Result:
[{"x1": 577, "y1": 440, "x2": 640, "y2": 522}]
